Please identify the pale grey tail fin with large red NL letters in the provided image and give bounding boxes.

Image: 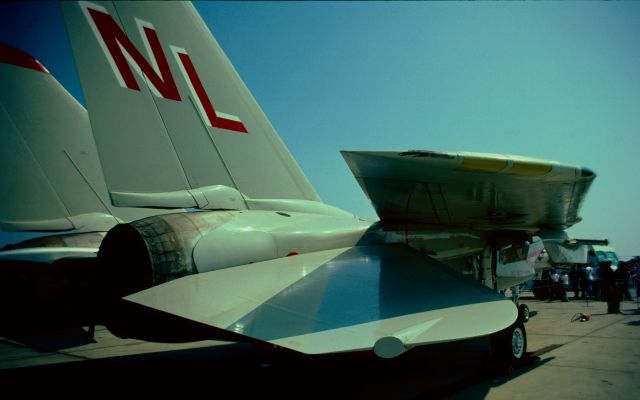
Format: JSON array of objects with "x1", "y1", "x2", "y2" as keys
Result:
[{"x1": 62, "y1": 1, "x2": 319, "y2": 209}]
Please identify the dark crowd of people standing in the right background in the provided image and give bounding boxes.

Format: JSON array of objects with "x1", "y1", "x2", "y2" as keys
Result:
[{"x1": 543, "y1": 260, "x2": 640, "y2": 313}]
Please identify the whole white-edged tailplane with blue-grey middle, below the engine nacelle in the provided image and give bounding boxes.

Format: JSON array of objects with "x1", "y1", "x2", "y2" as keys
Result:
[{"x1": 125, "y1": 245, "x2": 517, "y2": 356}]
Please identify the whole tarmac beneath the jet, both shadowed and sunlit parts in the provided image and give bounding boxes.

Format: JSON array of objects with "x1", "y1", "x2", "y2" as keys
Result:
[{"x1": 0, "y1": 292, "x2": 640, "y2": 400}]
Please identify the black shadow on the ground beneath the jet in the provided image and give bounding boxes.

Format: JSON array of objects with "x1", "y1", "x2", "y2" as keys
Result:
[{"x1": 0, "y1": 332, "x2": 548, "y2": 399}]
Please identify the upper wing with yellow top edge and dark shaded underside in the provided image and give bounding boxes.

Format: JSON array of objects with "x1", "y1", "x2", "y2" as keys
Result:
[{"x1": 342, "y1": 151, "x2": 595, "y2": 230}]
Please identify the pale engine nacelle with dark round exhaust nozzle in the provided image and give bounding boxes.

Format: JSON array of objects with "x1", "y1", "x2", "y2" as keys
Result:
[{"x1": 98, "y1": 211, "x2": 372, "y2": 297}]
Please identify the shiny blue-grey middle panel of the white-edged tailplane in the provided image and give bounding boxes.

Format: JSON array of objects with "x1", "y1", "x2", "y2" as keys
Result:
[{"x1": 228, "y1": 245, "x2": 504, "y2": 340}]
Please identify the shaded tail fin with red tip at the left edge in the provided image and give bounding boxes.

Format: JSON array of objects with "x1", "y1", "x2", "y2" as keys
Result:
[{"x1": 0, "y1": 44, "x2": 168, "y2": 231}]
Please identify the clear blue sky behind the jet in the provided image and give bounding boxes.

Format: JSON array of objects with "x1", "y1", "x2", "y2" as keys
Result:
[{"x1": 0, "y1": 2, "x2": 640, "y2": 257}]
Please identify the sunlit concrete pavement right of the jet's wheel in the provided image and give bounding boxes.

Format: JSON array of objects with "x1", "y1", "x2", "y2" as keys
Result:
[{"x1": 447, "y1": 298, "x2": 640, "y2": 400}]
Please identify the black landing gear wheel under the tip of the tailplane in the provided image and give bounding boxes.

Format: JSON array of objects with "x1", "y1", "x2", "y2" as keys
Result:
[{"x1": 491, "y1": 318, "x2": 527, "y2": 372}]
